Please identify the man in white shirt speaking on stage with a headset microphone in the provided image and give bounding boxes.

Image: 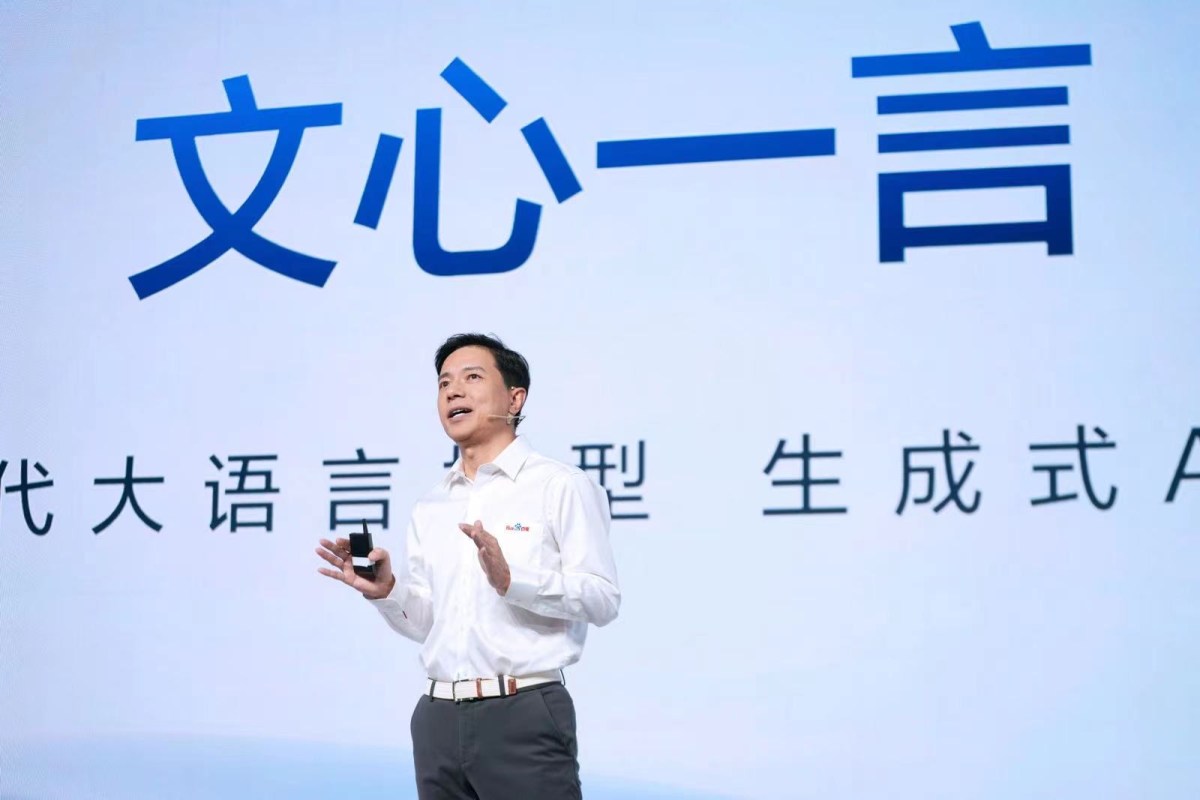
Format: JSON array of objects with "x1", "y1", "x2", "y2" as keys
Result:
[{"x1": 317, "y1": 333, "x2": 620, "y2": 800}]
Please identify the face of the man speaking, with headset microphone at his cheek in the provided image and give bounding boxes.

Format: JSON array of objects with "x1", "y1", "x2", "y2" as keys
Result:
[{"x1": 438, "y1": 347, "x2": 524, "y2": 446}]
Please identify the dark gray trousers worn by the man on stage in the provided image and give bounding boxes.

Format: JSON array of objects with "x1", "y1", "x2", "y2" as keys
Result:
[{"x1": 409, "y1": 684, "x2": 583, "y2": 800}]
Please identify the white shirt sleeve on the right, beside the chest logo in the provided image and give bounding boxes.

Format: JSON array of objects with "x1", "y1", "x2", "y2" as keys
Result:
[{"x1": 504, "y1": 471, "x2": 620, "y2": 626}]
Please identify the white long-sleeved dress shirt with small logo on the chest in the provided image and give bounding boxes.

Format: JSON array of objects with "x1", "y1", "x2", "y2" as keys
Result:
[{"x1": 371, "y1": 437, "x2": 620, "y2": 680}]
